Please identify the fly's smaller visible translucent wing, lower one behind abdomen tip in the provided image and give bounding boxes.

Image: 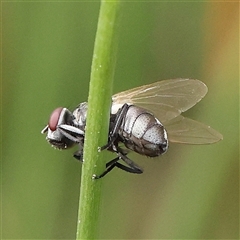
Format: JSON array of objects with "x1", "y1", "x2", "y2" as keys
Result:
[{"x1": 165, "y1": 115, "x2": 223, "y2": 144}]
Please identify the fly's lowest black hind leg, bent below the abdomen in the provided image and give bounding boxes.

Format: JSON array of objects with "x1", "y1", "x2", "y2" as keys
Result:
[{"x1": 93, "y1": 147, "x2": 143, "y2": 179}]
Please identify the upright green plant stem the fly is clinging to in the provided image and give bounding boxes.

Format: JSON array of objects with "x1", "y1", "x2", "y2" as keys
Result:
[{"x1": 77, "y1": 0, "x2": 120, "y2": 239}]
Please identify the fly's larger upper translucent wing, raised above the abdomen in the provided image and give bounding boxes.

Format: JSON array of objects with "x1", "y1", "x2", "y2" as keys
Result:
[{"x1": 113, "y1": 78, "x2": 207, "y2": 123}]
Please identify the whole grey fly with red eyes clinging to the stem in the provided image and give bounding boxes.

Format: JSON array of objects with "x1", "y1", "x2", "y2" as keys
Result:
[{"x1": 42, "y1": 78, "x2": 223, "y2": 179}]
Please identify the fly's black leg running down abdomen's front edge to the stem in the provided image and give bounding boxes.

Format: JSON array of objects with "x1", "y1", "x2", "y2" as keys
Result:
[{"x1": 100, "y1": 103, "x2": 129, "y2": 151}]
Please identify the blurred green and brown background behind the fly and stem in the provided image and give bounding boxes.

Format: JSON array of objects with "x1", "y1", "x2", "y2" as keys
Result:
[{"x1": 1, "y1": 1, "x2": 239, "y2": 239}]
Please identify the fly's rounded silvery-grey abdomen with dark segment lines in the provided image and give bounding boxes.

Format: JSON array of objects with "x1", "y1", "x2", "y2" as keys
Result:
[{"x1": 120, "y1": 106, "x2": 168, "y2": 157}]
